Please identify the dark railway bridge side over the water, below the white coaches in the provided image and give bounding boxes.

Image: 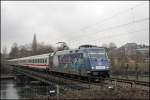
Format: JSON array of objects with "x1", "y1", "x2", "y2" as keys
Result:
[{"x1": 11, "y1": 65, "x2": 89, "y2": 90}]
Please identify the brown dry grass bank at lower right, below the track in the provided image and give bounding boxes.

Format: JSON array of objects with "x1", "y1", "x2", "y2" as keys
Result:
[{"x1": 31, "y1": 87, "x2": 149, "y2": 100}]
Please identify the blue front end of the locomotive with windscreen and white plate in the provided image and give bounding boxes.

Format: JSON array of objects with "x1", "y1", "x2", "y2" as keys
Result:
[{"x1": 87, "y1": 48, "x2": 110, "y2": 80}]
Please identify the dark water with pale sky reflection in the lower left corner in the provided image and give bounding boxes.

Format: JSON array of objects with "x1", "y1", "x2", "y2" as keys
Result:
[{"x1": 1, "y1": 80, "x2": 53, "y2": 99}]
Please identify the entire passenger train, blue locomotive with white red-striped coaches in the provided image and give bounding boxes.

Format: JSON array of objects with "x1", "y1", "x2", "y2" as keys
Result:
[{"x1": 8, "y1": 45, "x2": 110, "y2": 80}]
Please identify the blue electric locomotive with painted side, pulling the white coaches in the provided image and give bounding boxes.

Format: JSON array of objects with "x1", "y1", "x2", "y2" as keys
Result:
[{"x1": 52, "y1": 45, "x2": 110, "y2": 80}]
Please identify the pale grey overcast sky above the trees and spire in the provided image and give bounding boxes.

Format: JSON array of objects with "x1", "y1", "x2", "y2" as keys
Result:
[{"x1": 1, "y1": 1, "x2": 149, "y2": 52}]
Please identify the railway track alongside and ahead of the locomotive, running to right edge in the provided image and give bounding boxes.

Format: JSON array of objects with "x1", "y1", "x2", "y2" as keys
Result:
[{"x1": 12, "y1": 65, "x2": 150, "y2": 89}]
